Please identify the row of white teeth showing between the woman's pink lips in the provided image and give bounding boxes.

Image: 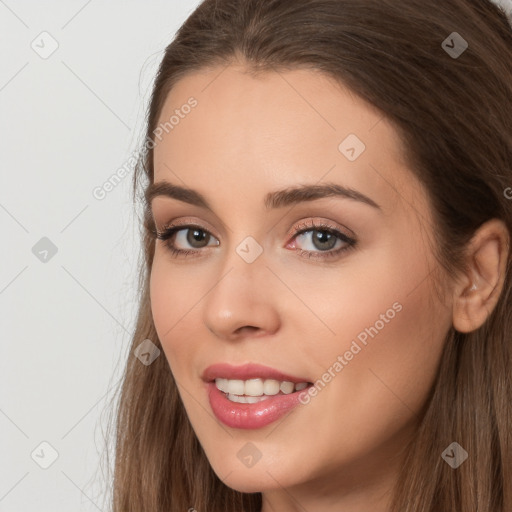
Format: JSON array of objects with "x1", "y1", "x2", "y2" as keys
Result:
[{"x1": 215, "y1": 378, "x2": 308, "y2": 396}]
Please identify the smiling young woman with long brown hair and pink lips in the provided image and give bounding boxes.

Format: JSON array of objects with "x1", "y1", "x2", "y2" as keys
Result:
[{"x1": 104, "y1": 0, "x2": 512, "y2": 512}]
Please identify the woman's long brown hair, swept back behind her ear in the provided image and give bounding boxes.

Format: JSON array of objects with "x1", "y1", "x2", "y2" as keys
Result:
[{"x1": 104, "y1": 0, "x2": 512, "y2": 512}]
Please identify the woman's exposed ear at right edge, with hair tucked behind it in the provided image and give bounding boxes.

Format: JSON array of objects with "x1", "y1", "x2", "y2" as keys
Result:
[{"x1": 453, "y1": 219, "x2": 510, "y2": 332}]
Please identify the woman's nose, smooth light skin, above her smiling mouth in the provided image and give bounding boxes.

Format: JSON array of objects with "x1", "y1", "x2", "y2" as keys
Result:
[{"x1": 203, "y1": 253, "x2": 280, "y2": 341}]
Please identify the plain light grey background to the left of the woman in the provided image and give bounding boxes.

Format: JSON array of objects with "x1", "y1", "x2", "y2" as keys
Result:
[{"x1": 0, "y1": 0, "x2": 203, "y2": 512}]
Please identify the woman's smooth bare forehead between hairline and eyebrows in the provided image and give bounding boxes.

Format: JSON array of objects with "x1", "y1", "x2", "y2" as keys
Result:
[{"x1": 154, "y1": 66, "x2": 426, "y2": 217}]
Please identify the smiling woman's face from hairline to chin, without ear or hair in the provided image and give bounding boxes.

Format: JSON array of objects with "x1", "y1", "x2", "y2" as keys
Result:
[{"x1": 150, "y1": 66, "x2": 452, "y2": 503}]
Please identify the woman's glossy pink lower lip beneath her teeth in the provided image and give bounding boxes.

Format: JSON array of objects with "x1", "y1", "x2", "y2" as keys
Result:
[{"x1": 207, "y1": 382, "x2": 308, "y2": 429}]
